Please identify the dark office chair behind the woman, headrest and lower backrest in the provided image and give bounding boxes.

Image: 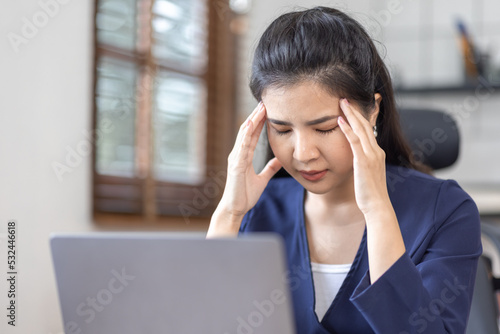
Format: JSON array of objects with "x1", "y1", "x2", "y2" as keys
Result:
[{"x1": 399, "y1": 109, "x2": 500, "y2": 334}]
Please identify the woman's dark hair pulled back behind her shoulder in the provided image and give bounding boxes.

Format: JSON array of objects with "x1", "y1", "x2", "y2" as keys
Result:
[{"x1": 250, "y1": 7, "x2": 428, "y2": 171}]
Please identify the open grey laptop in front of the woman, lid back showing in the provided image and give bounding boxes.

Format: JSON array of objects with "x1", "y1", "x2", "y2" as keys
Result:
[{"x1": 50, "y1": 232, "x2": 295, "y2": 334}]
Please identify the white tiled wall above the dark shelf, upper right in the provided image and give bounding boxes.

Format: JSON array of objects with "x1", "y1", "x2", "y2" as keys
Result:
[{"x1": 374, "y1": 0, "x2": 500, "y2": 87}]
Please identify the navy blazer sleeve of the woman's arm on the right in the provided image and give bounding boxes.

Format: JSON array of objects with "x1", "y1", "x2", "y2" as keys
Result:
[{"x1": 351, "y1": 181, "x2": 482, "y2": 334}]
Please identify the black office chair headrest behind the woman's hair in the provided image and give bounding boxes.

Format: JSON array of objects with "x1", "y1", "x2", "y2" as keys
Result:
[{"x1": 399, "y1": 109, "x2": 460, "y2": 169}]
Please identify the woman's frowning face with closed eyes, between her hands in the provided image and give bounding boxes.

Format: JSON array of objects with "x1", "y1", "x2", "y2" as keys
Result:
[{"x1": 262, "y1": 81, "x2": 353, "y2": 194}]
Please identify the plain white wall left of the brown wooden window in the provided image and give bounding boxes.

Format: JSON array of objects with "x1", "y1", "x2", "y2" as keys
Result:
[{"x1": 0, "y1": 0, "x2": 93, "y2": 334}]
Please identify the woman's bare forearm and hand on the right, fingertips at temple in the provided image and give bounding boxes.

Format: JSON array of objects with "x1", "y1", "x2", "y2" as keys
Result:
[{"x1": 338, "y1": 99, "x2": 406, "y2": 284}]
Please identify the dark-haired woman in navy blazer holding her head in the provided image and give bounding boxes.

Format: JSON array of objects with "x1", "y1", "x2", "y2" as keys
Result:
[{"x1": 207, "y1": 7, "x2": 482, "y2": 334}]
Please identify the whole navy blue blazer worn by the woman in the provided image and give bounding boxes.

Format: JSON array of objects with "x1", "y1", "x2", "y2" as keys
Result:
[{"x1": 240, "y1": 165, "x2": 482, "y2": 334}]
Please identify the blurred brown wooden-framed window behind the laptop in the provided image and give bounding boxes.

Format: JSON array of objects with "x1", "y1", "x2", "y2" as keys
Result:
[{"x1": 93, "y1": 0, "x2": 234, "y2": 222}]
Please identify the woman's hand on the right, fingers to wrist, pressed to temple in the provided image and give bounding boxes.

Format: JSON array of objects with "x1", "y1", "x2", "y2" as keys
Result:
[{"x1": 338, "y1": 99, "x2": 392, "y2": 216}]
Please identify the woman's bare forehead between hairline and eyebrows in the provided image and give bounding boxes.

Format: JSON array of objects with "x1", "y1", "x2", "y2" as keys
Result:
[{"x1": 262, "y1": 81, "x2": 340, "y2": 118}]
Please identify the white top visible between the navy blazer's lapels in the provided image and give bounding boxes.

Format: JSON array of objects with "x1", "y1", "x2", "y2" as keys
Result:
[{"x1": 311, "y1": 262, "x2": 351, "y2": 321}]
